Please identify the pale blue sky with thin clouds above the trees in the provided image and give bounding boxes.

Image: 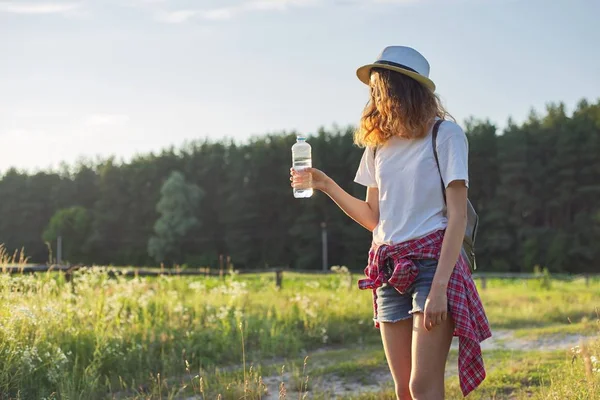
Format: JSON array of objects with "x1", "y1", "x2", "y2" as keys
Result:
[{"x1": 0, "y1": 0, "x2": 600, "y2": 174}]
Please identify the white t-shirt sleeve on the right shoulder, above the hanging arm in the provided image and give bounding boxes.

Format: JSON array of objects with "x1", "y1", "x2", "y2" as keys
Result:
[{"x1": 437, "y1": 122, "x2": 469, "y2": 187}]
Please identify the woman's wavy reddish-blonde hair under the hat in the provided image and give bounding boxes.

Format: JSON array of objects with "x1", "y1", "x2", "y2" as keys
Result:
[{"x1": 354, "y1": 68, "x2": 453, "y2": 147}]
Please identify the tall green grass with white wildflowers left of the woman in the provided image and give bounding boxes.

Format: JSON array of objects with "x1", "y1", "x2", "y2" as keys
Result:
[{"x1": 0, "y1": 268, "x2": 374, "y2": 399}]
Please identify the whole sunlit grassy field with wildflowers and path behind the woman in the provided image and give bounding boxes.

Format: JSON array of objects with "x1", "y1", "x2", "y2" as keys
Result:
[{"x1": 0, "y1": 269, "x2": 600, "y2": 399}]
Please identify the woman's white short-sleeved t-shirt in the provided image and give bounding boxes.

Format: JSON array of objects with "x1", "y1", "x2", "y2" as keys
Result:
[{"x1": 354, "y1": 121, "x2": 469, "y2": 245}]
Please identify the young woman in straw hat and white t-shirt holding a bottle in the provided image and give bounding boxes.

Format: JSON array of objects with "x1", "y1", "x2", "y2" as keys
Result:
[{"x1": 290, "y1": 46, "x2": 491, "y2": 400}]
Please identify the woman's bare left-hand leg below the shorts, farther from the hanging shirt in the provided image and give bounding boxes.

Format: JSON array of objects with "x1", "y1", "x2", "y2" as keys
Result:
[{"x1": 380, "y1": 318, "x2": 413, "y2": 400}]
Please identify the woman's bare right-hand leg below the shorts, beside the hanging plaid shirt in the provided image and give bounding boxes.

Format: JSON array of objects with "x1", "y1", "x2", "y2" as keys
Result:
[{"x1": 410, "y1": 313, "x2": 454, "y2": 400}]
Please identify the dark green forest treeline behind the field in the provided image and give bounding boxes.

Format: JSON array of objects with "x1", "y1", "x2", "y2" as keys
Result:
[{"x1": 0, "y1": 100, "x2": 600, "y2": 273}]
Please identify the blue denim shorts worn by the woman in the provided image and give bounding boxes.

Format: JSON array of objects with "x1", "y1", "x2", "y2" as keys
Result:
[{"x1": 376, "y1": 259, "x2": 438, "y2": 322}]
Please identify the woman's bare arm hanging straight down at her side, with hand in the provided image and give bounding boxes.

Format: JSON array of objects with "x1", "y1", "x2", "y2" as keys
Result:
[{"x1": 424, "y1": 180, "x2": 467, "y2": 330}]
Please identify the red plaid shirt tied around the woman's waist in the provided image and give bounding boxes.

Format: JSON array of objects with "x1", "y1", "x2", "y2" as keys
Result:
[{"x1": 358, "y1": 230, "x2": 492, "y2": 396}]
